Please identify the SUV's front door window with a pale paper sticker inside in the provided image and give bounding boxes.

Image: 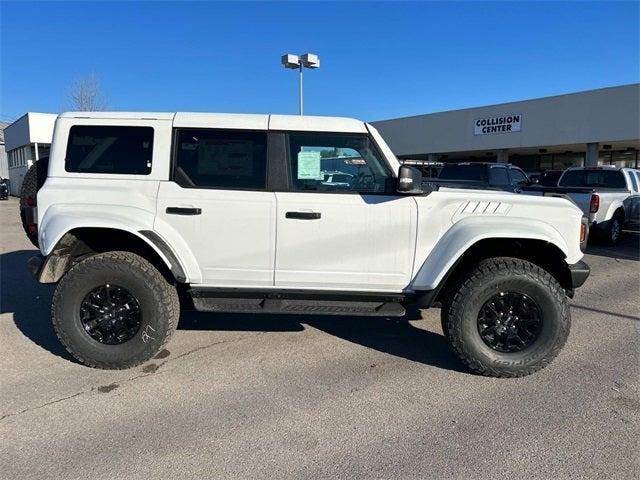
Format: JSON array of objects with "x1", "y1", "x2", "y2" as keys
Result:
[{"x1": 289, "y1": 133, "x2": 391, "y2": 193}]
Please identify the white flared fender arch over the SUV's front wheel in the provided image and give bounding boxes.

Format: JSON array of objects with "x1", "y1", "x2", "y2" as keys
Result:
[{"x1": 411, "y1": 216, "x2": 579, "y2": 291}]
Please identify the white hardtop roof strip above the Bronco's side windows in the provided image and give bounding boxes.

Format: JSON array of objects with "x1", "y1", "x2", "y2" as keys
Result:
[{"x1": 60, "y1": 112, "x2": 367, "y2": 133}]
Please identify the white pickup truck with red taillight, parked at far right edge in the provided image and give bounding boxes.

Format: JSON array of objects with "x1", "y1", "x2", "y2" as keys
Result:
[{"x1": 557, "y1": 166, "x2": 640, "y2": 245}]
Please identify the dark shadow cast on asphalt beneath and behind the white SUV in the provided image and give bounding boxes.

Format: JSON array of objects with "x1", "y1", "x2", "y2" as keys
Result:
[{"x1": 0, "y1": 250, "x2": 468, "y2": 373}]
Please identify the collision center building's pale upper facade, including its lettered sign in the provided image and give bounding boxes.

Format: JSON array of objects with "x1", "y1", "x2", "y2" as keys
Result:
[{"x1": 372, "y1": 84, "x2": 640, "y2": 172}]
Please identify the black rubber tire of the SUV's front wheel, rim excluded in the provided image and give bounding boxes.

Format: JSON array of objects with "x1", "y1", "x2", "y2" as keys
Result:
[{"x1": 442, "y1": 257, "x2": 571, "y2": 377}]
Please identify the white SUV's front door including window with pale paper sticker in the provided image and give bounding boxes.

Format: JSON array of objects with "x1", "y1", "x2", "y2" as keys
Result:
[{"x1": 275, "y1": 132, "x2": 417, "y2": 292}]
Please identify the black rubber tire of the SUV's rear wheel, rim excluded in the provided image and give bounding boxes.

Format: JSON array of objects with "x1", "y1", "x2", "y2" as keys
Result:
[{"x1": 51, "y1": 251, "x2": 180, "y2": 369}]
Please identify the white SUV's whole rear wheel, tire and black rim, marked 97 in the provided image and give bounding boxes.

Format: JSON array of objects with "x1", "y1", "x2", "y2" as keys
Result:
[{"x1": 51, "y1": 252, "x2": 180, "y2": 369}]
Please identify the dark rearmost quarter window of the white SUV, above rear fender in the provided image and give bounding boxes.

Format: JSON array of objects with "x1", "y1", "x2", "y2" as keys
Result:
[{"x1": 64, "y1": 125, "x2": 153, "y2": 175}]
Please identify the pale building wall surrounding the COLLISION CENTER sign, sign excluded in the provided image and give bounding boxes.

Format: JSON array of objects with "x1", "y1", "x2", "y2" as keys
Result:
[{"x1": 372, "y1": 84, "x2": 640, "y2": 156}]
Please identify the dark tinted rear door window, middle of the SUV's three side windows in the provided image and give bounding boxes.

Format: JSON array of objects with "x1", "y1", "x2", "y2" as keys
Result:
[{"x1": 174, "y1": 129, "x2": 267, "y2": 190}]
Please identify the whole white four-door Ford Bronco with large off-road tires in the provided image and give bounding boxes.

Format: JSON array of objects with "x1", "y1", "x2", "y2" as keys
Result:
[{"x1": 29, "y1": 112, "x2": 589, "y2": 377}]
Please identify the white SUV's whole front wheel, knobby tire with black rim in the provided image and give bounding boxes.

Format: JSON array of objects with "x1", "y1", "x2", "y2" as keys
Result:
[{"x1": 442, "y1": 257, "x2": 571, "y2": 377}]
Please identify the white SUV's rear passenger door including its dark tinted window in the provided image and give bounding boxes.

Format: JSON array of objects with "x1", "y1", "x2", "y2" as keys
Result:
[{"x1": 155, "y1": 123, "x2": 276, "y2": 287}]
